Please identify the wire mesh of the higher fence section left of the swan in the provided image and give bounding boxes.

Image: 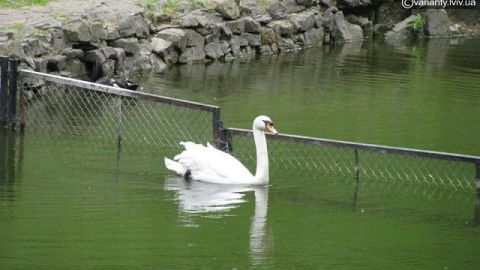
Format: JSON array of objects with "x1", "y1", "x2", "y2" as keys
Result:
[{"x1": 19, "y1": 70, "x2": 213, "y2": 154}]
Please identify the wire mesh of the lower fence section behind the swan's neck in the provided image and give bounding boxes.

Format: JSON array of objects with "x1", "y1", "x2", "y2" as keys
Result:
[{"x1": 229, "y1": 132, "x2": 476, "y2": 189}]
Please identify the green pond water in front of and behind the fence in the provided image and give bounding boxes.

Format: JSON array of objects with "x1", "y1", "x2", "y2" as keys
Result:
[{"x1": 0, "y1": 39, "x2": 480, "y2": 269}]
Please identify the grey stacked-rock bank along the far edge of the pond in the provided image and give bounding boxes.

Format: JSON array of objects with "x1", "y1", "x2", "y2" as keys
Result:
[{"x1": 0, "y1": 0, "x2": 474, "y2": 78}]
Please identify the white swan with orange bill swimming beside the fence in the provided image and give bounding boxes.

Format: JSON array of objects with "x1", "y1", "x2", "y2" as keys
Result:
[{"x1": 165, "y1": 115, "x2": 277, "y2": 185}]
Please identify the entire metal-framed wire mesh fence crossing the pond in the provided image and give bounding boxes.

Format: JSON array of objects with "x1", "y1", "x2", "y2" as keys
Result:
[{"x1": 0, "y1": 57, "x2": 480, "y2": 191}]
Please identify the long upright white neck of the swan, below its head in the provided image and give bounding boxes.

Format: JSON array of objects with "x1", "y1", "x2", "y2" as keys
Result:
[{"x1": 253, "y1": 128, "x2": 269, "y2": 185}]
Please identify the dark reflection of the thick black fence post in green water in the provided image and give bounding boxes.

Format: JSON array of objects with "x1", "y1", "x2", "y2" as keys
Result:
[{"x1": 0, "y1": 128, "x2": 24, "y2": 201}]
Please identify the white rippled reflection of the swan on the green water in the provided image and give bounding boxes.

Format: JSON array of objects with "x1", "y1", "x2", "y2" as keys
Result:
[{"x1": 165, "y1": 176, "x2": 273, "y2": 265}]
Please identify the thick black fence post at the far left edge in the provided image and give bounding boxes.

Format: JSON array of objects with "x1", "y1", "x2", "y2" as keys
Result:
[{"x1": 0, "y1": 56, "x2": 18, "y2": 127}]
